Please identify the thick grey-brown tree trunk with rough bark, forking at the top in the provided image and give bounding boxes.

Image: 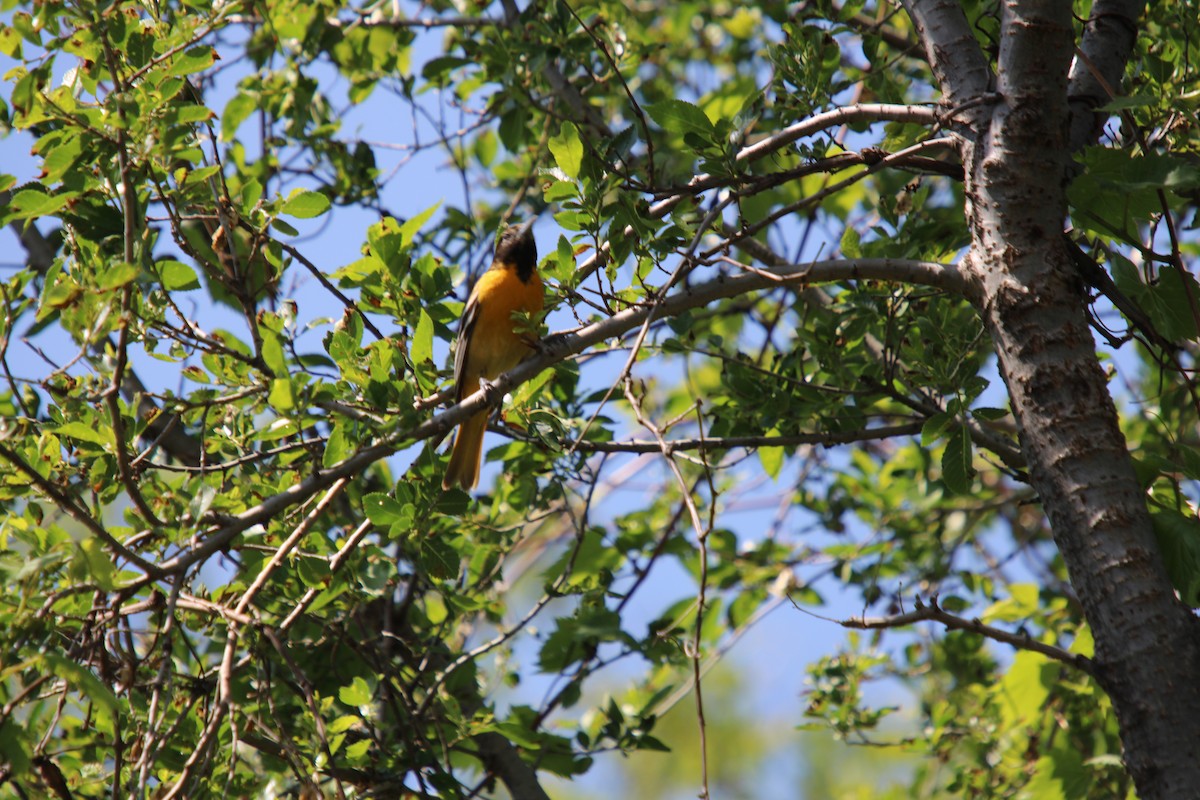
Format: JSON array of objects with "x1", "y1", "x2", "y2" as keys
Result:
[{"x1": 906, "y1": 0, "x2": 1200, "y2": 800}]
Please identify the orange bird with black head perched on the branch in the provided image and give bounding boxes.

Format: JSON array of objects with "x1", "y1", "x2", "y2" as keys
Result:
[{"x1": 442, "y1": 221, "x2": 545, "y2": 491}]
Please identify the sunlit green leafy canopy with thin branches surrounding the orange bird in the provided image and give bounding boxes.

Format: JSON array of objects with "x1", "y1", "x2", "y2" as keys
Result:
[{"x1": 0, "y1": 0, "x2": 1200, "y2": 798}]
